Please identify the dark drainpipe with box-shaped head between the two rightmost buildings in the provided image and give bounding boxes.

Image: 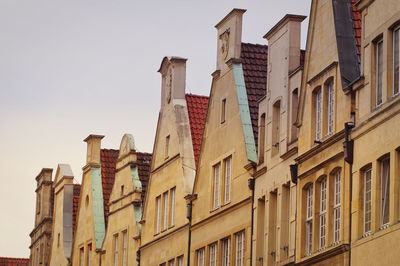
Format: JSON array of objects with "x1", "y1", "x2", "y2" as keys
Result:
[{"x1": 343, "y1": 120, "x2": 355, "y2": 266}]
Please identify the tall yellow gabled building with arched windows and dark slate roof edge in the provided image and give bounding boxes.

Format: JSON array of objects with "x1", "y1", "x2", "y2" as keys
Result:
[{"x1": 296, "y1": 0, "x2": 360, "y2": 265}]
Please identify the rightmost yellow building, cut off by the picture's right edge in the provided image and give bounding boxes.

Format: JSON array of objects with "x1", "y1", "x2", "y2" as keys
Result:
[{"x1": 349, "y1": 0, "x2": 400, "y2": 265}]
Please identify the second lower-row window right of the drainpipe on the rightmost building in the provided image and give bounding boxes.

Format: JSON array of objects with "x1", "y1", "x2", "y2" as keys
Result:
[{"x1": 381, "y1": 158, "x2": 390, "y2": 227}]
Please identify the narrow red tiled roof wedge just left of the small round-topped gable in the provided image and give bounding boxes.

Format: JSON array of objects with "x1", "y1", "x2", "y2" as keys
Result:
[{"x1": 100, "y1": 149, "x2": 119, "y2": 226}]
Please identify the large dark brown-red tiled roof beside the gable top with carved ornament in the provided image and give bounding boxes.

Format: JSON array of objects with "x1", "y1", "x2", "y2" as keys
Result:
[{"x1": 240, "y1": 43, "x2": 268, "y2": 147}]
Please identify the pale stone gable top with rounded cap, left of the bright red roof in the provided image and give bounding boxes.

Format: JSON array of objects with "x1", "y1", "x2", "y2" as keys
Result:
[{"x1": 158, "y1": 56, "x2": 187, "y2": 107}]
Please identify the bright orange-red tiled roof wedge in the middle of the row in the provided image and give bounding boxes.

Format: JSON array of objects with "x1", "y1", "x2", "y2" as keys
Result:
[{"x1": 186, "y1": 94, "x2": 208, "y2": 165}]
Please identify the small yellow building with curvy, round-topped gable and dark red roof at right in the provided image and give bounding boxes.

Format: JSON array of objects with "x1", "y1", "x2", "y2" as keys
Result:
[{"x1": 102, "y1": 134, "x2": 152, "y2": 266}]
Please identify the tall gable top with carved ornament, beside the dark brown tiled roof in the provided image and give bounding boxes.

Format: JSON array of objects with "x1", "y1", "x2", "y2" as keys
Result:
[{"x1": 215, "y1": 8, "x2": 246, "y2": 74}]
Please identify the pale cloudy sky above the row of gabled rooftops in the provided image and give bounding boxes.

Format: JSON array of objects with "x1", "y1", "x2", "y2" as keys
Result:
[{"x1": 0, "y1": 0, "x2": 311, "y2": 257}]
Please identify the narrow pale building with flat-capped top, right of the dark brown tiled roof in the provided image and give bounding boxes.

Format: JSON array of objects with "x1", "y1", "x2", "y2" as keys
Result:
[{"x1": 252, "y1": 15, "x2": 306, "y2": 265}]
